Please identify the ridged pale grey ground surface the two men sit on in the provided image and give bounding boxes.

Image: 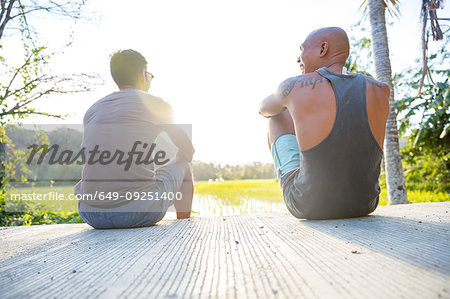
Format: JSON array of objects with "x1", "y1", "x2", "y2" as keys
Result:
[{"x1": 0, "y1": 202, "x2": 450, "y2": 298}]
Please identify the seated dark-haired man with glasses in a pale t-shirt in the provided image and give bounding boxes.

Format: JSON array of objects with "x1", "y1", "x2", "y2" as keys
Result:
[{"x1": 75, "y1": 50, "x2": 194, "y2": 229}]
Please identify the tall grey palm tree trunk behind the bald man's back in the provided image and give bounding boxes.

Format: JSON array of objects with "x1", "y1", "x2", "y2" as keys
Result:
[{"x1": 368, "y1": 0, "x2": 408, "y2": 205}]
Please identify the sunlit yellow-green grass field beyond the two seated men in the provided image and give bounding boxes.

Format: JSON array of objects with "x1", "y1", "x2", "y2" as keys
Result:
[{"x1": 7, "y1": 180, "x2": 450, "y2": 216}]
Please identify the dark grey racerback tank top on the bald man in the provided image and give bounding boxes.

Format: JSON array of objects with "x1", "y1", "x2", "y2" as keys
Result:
[{"x1": 285, "y1": 68, "x2": 383, "y2": 219}]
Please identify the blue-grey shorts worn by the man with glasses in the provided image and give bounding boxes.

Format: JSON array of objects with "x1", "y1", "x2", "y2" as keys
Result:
[{"x1": 78, "y1": 162, "x2": 191, "y2": 229}]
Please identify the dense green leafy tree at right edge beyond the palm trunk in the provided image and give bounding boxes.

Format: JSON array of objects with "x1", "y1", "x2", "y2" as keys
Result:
[{"x1": 396, "y1": 43, "x2": 450, "y2": 193}]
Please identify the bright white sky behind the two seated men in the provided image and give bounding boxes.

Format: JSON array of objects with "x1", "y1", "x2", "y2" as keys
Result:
[{"x1": 4, "y1": 0, "x2": 450, "y2": 165}]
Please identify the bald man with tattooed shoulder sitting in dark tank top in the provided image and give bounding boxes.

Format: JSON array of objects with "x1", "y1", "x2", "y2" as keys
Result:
[{"x1": 259, "y1": 27, "x2": 390, "y2": 219}]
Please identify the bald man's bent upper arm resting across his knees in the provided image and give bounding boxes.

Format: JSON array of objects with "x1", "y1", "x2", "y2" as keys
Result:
[{"x1": 259, "y1": 76, "x2": 300, "y2": 117}]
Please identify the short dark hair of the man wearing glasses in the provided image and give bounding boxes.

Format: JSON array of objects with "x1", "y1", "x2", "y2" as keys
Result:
[{"x1": 110, "y1": 49, "x2": 147, "y2": 87}]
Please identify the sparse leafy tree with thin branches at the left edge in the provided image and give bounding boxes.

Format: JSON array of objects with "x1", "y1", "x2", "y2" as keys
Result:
[{"x1": 0, "y1": 0, "x2": 97, "y2": 225}]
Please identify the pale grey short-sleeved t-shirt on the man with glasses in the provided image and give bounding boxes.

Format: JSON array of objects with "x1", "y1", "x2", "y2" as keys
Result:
[{"x1": 75, "y1": 89, "x2": 173, "y2": 207}]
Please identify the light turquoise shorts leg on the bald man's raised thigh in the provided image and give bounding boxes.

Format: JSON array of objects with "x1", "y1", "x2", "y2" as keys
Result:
[{"x1": 272, "y1": 134, "x2": 300, "y2": 187}]
